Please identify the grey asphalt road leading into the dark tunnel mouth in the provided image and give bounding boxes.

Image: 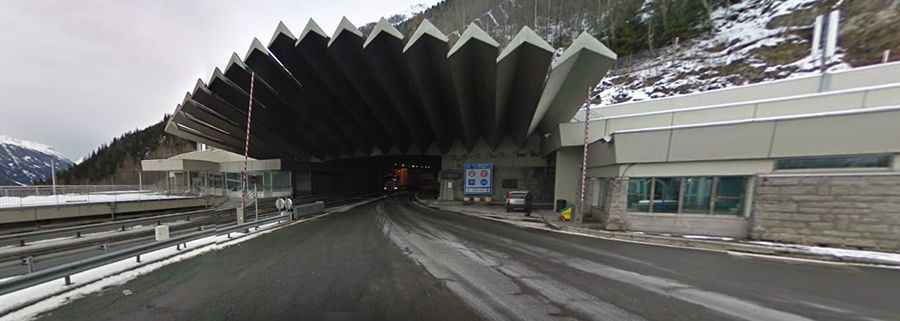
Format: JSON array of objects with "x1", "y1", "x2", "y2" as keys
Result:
[{"x1": 29, "y1": 198, "x2": 900, "y2": 321}]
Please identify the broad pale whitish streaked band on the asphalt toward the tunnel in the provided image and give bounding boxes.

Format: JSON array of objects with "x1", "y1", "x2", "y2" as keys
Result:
[{"x1": 378, "y1": 202, "x2": 645, "y2": 321}]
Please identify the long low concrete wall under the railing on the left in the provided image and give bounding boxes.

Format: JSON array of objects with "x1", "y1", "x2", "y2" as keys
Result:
[{"x1": 0, "y1": 198, "x2": 214, "y2": 224}]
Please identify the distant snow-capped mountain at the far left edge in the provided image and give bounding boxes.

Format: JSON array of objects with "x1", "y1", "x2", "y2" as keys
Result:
[{"x1": 0, "y1": 135, "x2": 73, "y2": 186}]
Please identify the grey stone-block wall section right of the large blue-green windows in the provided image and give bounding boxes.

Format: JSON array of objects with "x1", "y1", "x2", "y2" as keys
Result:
[{"x1": 751, "y1": 175, "x2": 900, "y2": 251}]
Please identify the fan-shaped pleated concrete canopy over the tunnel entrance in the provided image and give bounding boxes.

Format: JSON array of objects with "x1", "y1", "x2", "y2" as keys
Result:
[{"x1": 166, "y1": 18, "x2": 616, "y2": 160}]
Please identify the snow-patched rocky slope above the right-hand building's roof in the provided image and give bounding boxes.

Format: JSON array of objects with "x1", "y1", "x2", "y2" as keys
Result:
[{"x1": 593, "y1": 0, "x2": 849, "y2": 106}]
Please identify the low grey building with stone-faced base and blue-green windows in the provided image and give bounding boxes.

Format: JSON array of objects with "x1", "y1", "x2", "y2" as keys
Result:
[{"x1": 544, "y1": 63, "x2": 900, "y2": 250}]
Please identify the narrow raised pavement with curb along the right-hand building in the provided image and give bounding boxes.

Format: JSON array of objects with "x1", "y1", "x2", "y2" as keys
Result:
[{"x1": 415, "y1": 195, "x2": 900, "y2": 269}]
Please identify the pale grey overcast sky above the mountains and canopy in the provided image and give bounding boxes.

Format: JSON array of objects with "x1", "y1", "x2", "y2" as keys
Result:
[{"x1": 0, "y1": 0, "x2": 436, "y2": 160}]
